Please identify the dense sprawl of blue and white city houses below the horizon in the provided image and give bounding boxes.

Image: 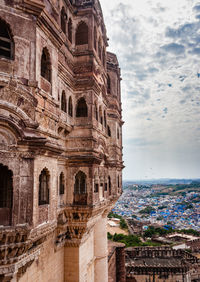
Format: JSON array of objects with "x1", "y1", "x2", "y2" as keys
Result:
[{"x1": 113, "y1": 182, "x2": 200, "y2": 231}]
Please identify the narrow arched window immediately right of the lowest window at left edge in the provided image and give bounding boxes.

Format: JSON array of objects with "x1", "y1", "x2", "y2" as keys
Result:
[{"x1": 39, "y1": 168, "x2": 50, "y2": 206}]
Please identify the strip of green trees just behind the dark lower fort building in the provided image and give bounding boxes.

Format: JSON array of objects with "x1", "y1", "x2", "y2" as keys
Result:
[{"x1": 108, "y1": 232, "x2": 160, "y2": 247}]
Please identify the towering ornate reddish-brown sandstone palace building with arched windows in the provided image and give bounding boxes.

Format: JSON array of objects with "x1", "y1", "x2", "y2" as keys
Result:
[{"x1": 0, "y1": 0, "x2": 123, "y2": 282}]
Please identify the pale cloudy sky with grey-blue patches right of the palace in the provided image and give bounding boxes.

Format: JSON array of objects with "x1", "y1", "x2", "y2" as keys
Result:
[{"x1": 100, "y1": 0, "x2": 200, "y2": 180}]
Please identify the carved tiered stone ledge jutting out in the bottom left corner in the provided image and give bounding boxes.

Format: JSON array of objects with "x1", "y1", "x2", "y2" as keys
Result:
[{"x1": 0, "y1": 222, "x2": 56, "y2": 281}]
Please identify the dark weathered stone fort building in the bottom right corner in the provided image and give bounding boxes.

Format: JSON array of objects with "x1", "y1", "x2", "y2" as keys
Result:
[{"x1": 126, "y1": 247, "x2": 198, "y2": 282}]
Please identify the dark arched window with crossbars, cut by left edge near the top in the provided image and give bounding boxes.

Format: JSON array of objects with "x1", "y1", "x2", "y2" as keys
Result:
[{"x1": 0, "y1": 19, "x2": 14, "y2": 60}]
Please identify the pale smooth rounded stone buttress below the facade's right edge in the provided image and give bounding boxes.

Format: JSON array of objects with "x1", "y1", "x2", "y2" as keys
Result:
[{"x1": 94, "y1": 217, "x2": 108, "y2": 282}]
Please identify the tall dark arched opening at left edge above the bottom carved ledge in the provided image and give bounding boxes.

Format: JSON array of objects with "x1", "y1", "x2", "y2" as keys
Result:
[{"x1": 0, "y1": 164, "x2": 13, "y2": 225}]
